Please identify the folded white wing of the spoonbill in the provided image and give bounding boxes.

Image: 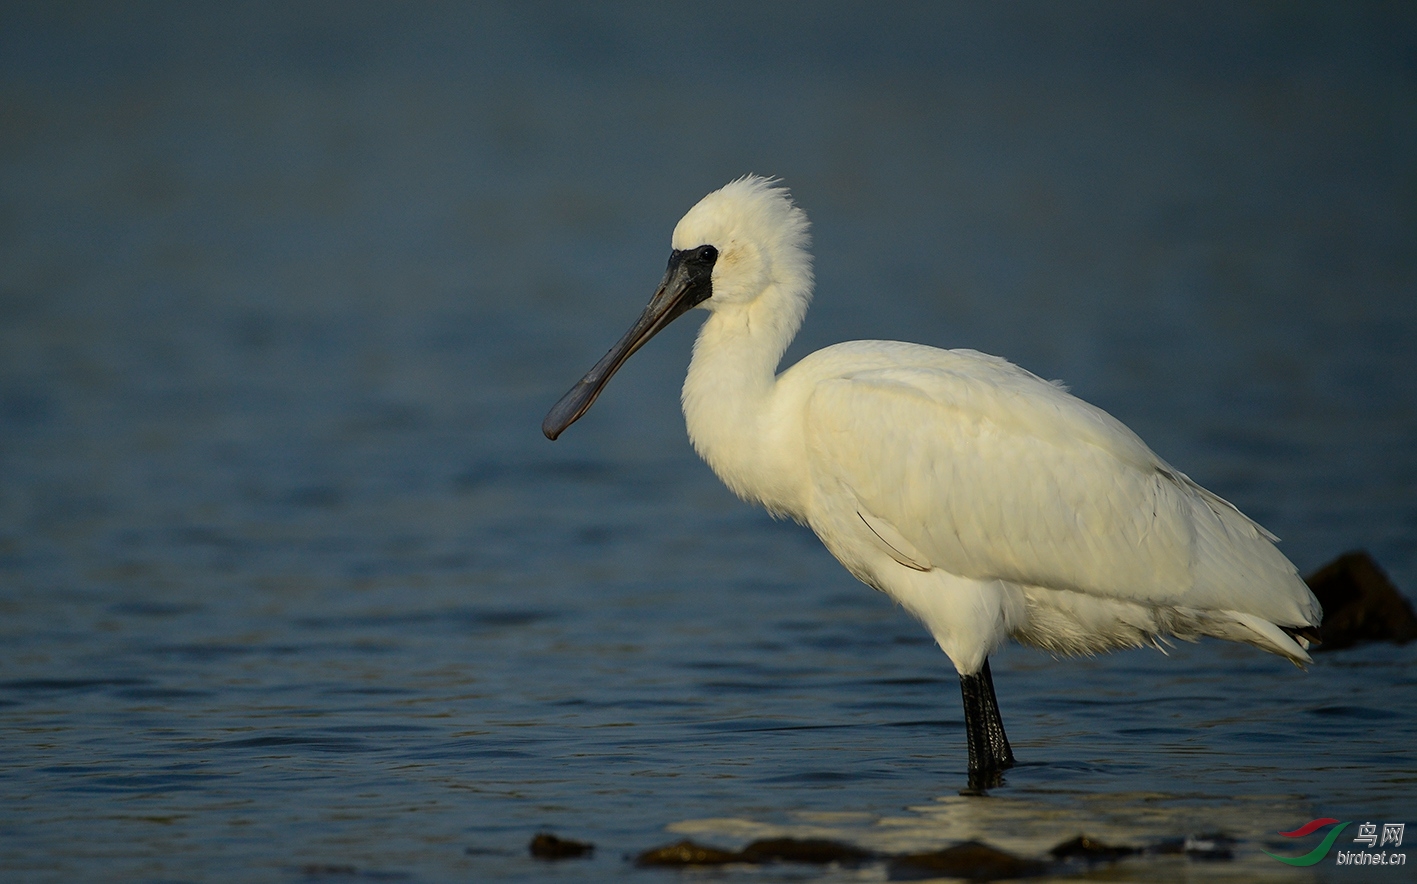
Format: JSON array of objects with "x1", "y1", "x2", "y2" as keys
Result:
[{"x1": 805, "y1": 350, "x2": 1314, "y2": 625}]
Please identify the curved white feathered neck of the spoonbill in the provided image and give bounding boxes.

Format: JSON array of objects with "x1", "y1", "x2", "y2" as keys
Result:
[{"x1": 683, "y1": 286, "x2": 808, "y2": 516}]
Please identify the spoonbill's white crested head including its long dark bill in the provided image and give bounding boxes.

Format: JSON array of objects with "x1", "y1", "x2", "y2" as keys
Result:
[{"x1": 541, "y1": 176, "x2": 812, "y2": 439}]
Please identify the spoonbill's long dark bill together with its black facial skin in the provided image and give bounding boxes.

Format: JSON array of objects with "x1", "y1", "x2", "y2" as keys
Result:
[{"x1": 541, "y1": 245, "x2": 718, "y2": 441}]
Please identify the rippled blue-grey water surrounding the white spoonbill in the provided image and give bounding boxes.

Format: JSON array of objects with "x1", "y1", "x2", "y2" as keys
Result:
[{"x1": 0, "y1": 3, "x2": 1417, "y2": 881}]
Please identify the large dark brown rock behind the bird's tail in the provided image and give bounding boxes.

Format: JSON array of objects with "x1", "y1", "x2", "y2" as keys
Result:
[{"x1": 1306, "y1": 550, "x2": 1417, "y2": 650}]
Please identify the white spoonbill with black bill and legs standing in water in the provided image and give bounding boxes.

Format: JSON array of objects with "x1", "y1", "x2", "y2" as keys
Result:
[{"x1": 541, "y1": 176, "x2": 1322, "y2": 792}]
